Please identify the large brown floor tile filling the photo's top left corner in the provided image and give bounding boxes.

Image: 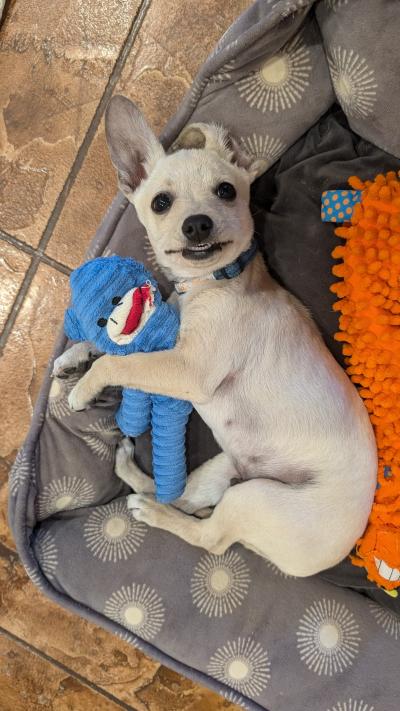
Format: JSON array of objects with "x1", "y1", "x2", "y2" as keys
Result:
[{"x1": 0, "y1": 0, "x2": 139, "y2": 245}]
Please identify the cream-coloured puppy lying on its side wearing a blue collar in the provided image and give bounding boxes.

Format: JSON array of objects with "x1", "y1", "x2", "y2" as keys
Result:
[{"x1": 55, "y1": 96, "x2": 377, "y2": 577}]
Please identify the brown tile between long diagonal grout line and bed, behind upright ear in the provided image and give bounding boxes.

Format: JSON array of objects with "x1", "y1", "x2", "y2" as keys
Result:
[{"x1": 47, "y1": 0, "x2": 251, "y2": 267}]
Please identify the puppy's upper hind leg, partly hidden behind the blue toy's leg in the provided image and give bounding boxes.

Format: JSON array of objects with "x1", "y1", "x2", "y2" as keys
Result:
[{"x1": 115, "y1": 437, "x2": 237, "y2": 513}]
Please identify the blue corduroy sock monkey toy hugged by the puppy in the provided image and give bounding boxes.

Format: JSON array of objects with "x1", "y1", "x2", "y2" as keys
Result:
[{"x1": 64, "y1": 256, "x2": 192, "y2": 503}]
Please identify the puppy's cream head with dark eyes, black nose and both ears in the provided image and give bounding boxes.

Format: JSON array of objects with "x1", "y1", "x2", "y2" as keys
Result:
[{"x1": 106, "y1": 96, "x2": 260, "y2": 279}]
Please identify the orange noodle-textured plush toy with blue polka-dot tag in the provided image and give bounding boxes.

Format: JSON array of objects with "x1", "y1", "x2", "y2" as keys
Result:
[{"x1": 321, "y1": 172, "x2": 400, "y2": 596}]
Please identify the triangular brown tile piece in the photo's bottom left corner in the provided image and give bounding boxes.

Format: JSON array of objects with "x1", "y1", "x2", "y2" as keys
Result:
[{"x1": 0, "y1": 634, "x2": 126, "y2": 711}]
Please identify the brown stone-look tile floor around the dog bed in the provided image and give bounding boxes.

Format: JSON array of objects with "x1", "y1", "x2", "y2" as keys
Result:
[{"x1": 0, "y1": 0, "x2": 250, "y2": 711}]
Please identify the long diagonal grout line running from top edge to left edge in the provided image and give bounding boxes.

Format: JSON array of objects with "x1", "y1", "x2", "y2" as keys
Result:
[{"x1": 0, "y1": 0, "x2": 151, "y2": 355}]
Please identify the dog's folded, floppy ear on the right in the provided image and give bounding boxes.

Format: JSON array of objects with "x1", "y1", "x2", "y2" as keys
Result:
[{"x1": 172, "y1": 123, "x2": 267, "y2": 182}]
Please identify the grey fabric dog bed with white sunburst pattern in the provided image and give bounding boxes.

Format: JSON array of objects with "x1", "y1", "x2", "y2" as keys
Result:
[{"x1": 9, "y1": 0, "x2": 400, "y2": 711}]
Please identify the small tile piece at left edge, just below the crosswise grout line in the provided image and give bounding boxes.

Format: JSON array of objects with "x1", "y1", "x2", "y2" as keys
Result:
[{"x1": 0, "y1": 240, "x2": 31, "y2": 331}]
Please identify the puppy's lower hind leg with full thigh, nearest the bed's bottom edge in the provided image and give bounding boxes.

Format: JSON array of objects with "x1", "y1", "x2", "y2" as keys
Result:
[{"x1": 128, "y1": 479, "x2": 346, "y2": 577}]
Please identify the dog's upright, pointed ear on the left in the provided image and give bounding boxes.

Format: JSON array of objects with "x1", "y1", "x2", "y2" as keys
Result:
[{"x1": 105, "y1": 95, "x2": 165, "y2": 198}]
